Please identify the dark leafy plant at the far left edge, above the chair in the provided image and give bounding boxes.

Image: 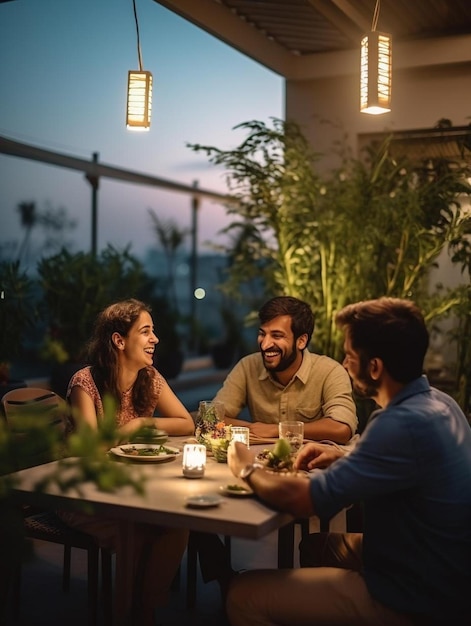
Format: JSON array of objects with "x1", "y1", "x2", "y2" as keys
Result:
[{"x1": 0, "y1": 261, "x2": 36, "y2": 395}]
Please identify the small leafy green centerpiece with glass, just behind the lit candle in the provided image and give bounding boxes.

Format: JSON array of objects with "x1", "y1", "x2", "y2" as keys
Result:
[{"x1": 195, "y1": 400, "x2": 232, "y2": 463}]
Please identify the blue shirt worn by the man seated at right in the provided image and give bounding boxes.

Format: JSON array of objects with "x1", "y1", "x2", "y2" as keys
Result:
[{"x1": 310, "y1": 376, "x2": 471, "y2": 623}]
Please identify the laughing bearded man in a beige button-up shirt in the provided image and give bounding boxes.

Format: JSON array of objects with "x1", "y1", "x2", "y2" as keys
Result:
[{"x1": 214, "y1": 296, "x2": 358, "y2": 444}]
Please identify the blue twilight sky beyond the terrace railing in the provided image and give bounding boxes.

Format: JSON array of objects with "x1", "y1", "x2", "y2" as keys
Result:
[{"x1": 0, "y1": 0, "x2": 284, "y2": 256}]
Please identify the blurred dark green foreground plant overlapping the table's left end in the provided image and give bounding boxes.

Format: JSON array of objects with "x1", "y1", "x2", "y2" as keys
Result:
[{"x1": 0, "y1": 398, "x2": 145, "y2": 624}]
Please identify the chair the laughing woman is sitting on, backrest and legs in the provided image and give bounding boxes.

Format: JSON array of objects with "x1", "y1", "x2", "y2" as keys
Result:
[{"x1": 1, "y1": 387, "x2": 112, "y2": 626}]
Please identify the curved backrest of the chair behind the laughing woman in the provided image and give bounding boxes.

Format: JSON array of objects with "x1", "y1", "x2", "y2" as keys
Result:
[{"x1": 1, "y1": 387, "x2": 68, "y2": 468}]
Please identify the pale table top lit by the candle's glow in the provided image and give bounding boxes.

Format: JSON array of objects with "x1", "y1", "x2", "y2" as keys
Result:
[{"x1": 9, "y1": 438, "x2": 293, "y2": 539}]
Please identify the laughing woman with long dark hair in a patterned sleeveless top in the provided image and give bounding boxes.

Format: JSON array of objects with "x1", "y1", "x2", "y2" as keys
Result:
[{"x1": 61, "y1": 299, "x2": 194, "y2": 626}]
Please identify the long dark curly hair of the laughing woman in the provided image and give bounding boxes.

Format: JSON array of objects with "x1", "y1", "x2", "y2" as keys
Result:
[{"x1": 88, "y1": 299, "x2": 156, "y2": 415}]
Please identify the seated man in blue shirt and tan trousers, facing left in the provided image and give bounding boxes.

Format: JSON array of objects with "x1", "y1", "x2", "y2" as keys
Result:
[{"x1": 227, "y1": 298, "x2": 471, "y2": 626}]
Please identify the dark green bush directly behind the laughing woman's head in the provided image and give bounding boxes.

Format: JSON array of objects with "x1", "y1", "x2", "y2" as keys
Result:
[{"x1": 38, "y1": 245, "x2": 154, "y2": 361}]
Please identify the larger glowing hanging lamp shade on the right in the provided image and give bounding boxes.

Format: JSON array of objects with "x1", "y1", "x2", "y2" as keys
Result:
[{"x1": 360, "y1": 31, "x2": 392, "y2": 115}]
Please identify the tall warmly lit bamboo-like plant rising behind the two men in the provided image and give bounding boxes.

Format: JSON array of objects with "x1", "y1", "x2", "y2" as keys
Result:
[{"x1": 190, "y1": 120, "x2": 471, "y2": 359}]
